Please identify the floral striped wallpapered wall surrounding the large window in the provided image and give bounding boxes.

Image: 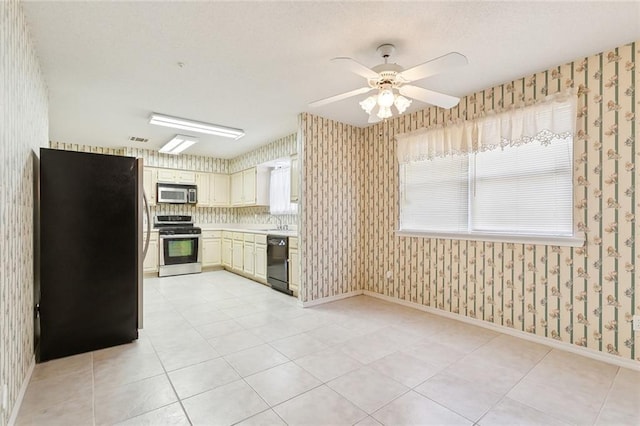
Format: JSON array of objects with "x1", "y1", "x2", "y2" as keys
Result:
[{"x1": 358, "y1": 43, "x2": 640, "y2": 360}]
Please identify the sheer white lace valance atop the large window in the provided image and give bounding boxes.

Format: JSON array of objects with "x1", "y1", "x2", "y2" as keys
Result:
[{"x1": 396, "y1": 91, "x2": 578, "y2": 164}]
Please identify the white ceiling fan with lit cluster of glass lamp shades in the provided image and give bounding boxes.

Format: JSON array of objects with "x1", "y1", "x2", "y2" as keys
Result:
[{"x1": 309, "y1": 44, "x2": 468, "y2": 123}]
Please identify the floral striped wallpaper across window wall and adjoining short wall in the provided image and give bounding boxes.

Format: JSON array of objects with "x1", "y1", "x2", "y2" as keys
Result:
[{"x1": 299, "y1": 42, "x2": 640, "y2": 360}]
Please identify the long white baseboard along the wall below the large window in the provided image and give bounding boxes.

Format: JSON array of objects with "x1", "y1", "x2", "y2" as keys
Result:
[{"x1": 362, "y1": 290, "x2": 640, "y2": 371}]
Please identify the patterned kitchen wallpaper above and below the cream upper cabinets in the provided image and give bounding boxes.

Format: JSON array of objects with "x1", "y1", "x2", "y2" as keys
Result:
[{"x1": 50, "y1": 133, "x2": 298, "y2": 225}]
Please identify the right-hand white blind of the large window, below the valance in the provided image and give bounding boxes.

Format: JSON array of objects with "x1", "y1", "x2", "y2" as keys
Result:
[{"x1": 470, "y1": 138, "x2": 573, "y2": 236}]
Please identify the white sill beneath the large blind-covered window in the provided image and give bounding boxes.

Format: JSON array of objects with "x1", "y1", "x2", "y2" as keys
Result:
[{"x1": 395, "y1": 229, "x2": 585, "y2": 247}]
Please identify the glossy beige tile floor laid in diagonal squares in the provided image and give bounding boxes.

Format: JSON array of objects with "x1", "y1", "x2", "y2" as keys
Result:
[{"x1": 17, "y1": 271, "x2": 640, "y2": 425}]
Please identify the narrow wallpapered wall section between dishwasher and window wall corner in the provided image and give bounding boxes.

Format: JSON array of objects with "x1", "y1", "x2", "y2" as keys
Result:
[{"x1": 298, "y1": 113, "x2": 362, "y2": 302}]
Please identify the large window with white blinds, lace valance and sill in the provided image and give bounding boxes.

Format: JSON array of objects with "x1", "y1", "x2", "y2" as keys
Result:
[{"x1": 396, "y1": 93, "x2": 583, "y2": 245}]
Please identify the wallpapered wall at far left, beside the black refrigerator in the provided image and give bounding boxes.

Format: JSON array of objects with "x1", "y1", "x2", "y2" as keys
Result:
[{"x1": 0, "y1": 0, "x2": 49, "y2": 425}]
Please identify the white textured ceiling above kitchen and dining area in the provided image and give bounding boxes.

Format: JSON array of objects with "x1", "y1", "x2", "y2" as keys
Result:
[{"x1": 23, "y1": 1, "x2": 640, "y2": 158}]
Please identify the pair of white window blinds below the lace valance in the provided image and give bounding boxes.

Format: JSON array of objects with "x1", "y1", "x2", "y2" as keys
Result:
[{"x1": 400, "y1": 138, "x2": 573, "y2": 241}]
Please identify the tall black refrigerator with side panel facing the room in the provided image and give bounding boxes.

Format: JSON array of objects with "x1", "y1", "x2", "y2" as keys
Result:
[{"x1": 35, "y1": 148, "x2": 143, "y2": 362}]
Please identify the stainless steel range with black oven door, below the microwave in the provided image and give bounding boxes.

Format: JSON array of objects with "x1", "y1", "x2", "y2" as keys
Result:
[{"x1": 153, "y1": 215, "x2": 202, "y2": 277}]
